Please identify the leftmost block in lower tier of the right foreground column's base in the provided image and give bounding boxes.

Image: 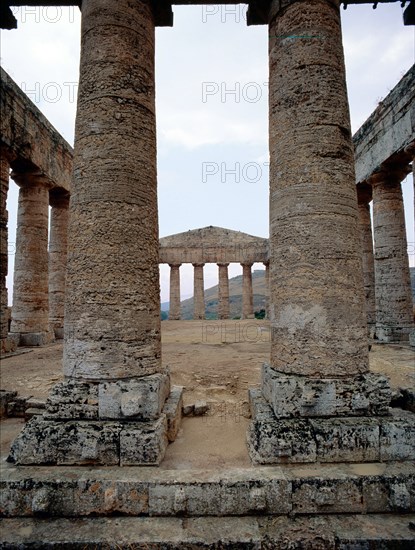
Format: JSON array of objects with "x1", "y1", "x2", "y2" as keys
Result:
[{"x1": 247, "y1": 390, "x2": 317, "y2": 464}]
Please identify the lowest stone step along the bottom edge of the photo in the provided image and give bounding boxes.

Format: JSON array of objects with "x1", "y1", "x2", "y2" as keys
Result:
[{"x1": 0, "y1": 515, "x2": 415, "y2": 550}]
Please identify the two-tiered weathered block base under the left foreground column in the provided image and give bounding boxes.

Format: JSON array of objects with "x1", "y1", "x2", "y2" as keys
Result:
[{"x1": 8, "y1": 373, "x2": 183, "y2": 466}]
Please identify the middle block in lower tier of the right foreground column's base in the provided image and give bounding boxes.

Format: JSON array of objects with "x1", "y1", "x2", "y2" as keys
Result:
[{"x1": 310, "y1": 417, "x2": 380, "y2": 462}]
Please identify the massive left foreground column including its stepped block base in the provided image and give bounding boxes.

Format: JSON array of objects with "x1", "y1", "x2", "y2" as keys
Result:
[{"x1": 9, "y1": 0, "x2": 181, "y2": 466}]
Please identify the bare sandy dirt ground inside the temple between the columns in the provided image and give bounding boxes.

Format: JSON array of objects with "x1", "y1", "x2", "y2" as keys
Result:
[{"x1": 0, "y1": 320, "x2": 415, "y2": 469}]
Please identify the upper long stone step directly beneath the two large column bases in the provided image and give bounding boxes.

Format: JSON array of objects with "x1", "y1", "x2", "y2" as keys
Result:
[{"x1": 0, "y1": 462, "x2": 415, "y2": 518}]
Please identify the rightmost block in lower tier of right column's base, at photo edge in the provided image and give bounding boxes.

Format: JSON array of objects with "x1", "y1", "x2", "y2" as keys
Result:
[{"x1": 380, "y1": 410, "x2": 415, "y2": 460}]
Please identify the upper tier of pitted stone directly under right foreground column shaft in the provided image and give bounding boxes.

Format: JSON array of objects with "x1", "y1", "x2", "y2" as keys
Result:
[{"x1": 262, "y1": 363, "x2": 392, "y2": 418}]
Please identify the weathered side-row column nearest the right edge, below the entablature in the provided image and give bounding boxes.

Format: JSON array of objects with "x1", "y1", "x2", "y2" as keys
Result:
[{"x1": 371, "y1": 170, "x2": 414, "y2": 342}]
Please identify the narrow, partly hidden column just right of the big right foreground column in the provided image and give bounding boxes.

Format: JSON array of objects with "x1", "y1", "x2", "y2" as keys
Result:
[{"x1": 357, "y1": 184, "x2": 376, "y2": 338}]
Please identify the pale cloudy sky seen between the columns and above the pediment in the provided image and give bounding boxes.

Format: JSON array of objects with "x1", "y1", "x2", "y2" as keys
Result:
[{"x1": 1, "y1": 2, "x2": 415, "y2": 301}]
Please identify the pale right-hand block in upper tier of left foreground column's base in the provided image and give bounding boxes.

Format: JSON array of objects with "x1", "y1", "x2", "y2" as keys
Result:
[{"x1": 98, "y1": 373, "x2": 170, "y2": 420}]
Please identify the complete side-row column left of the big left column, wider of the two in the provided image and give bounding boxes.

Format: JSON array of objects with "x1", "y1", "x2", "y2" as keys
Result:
[{"x1": 10, "y1": 172, "x2": 53, "y2": 346}]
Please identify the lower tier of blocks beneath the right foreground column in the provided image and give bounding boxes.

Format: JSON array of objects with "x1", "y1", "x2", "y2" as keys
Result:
[{"x1": 247, "y1": 390, "x2": 415, "y2": 464}]
